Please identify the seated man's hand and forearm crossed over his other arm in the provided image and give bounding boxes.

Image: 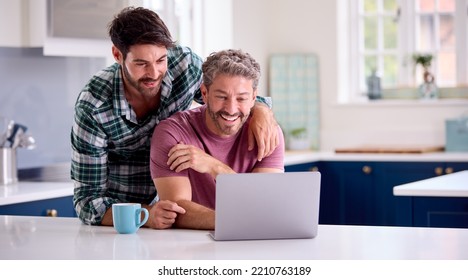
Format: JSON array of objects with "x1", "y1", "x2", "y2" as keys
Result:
[{"x1": 167, "y1": 143, "x2": 234, "y2": 178}]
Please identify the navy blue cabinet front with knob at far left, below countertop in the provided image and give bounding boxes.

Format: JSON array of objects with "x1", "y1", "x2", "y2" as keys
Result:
[{"x1": 0, "y1": 196, "x2": 76, "y2": 217}]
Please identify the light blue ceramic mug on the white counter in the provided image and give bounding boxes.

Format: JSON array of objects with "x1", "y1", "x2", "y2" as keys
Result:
[{"x1": 112, "y1": 203, "x2": 149, "y2": 233}]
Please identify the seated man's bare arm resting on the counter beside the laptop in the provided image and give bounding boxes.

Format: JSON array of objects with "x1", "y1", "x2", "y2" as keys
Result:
[{"x1": 154, "y1": 177, "x2": 215, "y2": 230}]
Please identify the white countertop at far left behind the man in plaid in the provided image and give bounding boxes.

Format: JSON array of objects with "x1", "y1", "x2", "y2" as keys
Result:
[{"x1": 0, "y1": 181, "x2": 73, "y2": 206}]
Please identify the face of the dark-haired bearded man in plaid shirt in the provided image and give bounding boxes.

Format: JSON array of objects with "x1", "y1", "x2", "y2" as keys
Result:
[{"x1": 112, "y1": 44, "x2": 167, "y2": 97}]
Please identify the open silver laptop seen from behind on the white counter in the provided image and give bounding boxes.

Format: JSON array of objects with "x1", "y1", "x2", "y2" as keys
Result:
[{"x1": 211, "y1": 171, "x2": 320, "y2": 240}]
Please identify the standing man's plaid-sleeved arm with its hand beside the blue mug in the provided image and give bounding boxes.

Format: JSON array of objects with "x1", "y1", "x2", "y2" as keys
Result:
[{"x1": 71, "y1": 104, "x2": 185, "y2": 229}]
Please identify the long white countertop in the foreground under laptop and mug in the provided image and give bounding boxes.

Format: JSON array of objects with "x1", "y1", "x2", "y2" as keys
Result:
[{"x1": 0, "y1": 216, "x2": 468, "y2": 260}]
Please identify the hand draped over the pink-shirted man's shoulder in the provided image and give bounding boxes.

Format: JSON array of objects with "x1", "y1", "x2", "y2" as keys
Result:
[{"x1": 249, "y1": 102, "x2": 279, "y2": 161}]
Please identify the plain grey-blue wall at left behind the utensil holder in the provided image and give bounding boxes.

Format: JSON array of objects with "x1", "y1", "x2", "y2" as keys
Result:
[{"x1": 0, "y1": 48, "x2": 105, "y2": 169}]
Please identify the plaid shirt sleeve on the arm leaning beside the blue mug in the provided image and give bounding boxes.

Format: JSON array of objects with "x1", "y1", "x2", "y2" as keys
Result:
[{"x1": 71, "y1": 105, "x2": 116, "y2": 225}]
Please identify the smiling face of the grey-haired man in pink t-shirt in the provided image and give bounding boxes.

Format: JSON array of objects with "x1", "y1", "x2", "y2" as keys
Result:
[{"x1": 201, "y1": 74, "x2": 257, "y2": 136}]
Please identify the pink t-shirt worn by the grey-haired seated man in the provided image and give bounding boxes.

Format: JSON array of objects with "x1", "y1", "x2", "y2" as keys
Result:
[{"x1": 150, "y1": 106, "x2": 284, "y2": 209}]
